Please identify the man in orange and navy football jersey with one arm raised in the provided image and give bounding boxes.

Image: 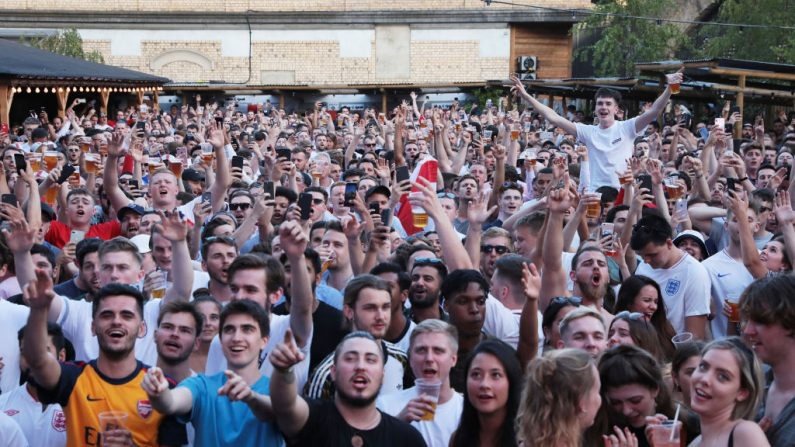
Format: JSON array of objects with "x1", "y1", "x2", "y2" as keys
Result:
[{"x1": 23, "y1": 278, "x2": 184, "y2": 447}]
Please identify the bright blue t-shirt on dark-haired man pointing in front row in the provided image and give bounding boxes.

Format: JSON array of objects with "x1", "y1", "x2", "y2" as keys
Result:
[{"x1": 179, "y1": 373, "x2": 284, "y2": 447}]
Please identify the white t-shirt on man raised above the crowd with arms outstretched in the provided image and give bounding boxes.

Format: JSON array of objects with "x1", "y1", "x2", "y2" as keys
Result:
[{"x1": 575, "y1": 117, "x2": 641, "y2": 189}]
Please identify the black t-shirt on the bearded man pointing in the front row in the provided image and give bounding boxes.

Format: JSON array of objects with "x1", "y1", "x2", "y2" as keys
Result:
[{"x1": 287, "y1": 400, "x2": 426, "y2": 447}]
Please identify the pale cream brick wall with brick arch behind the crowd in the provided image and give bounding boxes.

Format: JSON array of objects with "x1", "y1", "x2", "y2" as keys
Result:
[{"x1": 84, "y1": 40, "x2": 512, "y2": 86}]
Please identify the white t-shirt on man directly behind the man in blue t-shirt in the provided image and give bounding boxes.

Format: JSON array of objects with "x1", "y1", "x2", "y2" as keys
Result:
[{"x1": 204, "y1": 314, "x2": 314, "y2": 390}]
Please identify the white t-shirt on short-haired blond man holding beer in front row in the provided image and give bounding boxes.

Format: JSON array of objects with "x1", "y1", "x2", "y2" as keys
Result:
[{"x1": 375, "y1": 387, "x2": 464, "y2": 447}]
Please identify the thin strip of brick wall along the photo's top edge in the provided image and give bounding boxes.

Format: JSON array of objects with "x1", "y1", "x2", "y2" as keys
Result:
[{"x1": 0, "y1": 0, "x2": 592, "y2": 13}]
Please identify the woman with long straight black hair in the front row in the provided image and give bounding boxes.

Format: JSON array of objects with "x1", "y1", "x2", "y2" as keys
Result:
[{"x1": 450, "y1": 339, "x2": 522, "y2": 447}]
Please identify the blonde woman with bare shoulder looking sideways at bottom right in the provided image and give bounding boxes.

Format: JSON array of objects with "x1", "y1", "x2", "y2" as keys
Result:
[{"x1": 690, "y1": 337, "x2": 770, "y2": 447}]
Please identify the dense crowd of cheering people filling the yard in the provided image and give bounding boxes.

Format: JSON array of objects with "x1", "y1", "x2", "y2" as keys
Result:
[{"x1": 0, "y1": 67, "x2": 795, "y2": 447}]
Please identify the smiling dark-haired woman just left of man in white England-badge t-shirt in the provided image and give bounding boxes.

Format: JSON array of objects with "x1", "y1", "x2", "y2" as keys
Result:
[{"x1": 614, "y1": 275, "x2": 676, "y2": 361}]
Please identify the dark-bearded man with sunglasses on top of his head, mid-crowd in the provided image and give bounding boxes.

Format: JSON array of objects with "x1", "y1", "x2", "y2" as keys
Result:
[{"x1": 408, "y1": 258, "x2": 447, "y2": 323}]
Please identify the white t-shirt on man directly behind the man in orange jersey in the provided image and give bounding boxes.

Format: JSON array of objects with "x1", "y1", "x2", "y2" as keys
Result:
[{"x1": 57, "y1": 296, "x2": 162, "y2": 366}]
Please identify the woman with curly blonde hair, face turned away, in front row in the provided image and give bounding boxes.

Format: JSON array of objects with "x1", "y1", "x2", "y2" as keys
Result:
[{"x1": 516, "y1": 349, "x2": 602, "y2": 447}]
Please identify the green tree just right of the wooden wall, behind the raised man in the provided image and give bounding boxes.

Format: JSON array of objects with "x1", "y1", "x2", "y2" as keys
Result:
[{"x1": 575, "y1": 0, "x2": 685, "y2": 77}]
